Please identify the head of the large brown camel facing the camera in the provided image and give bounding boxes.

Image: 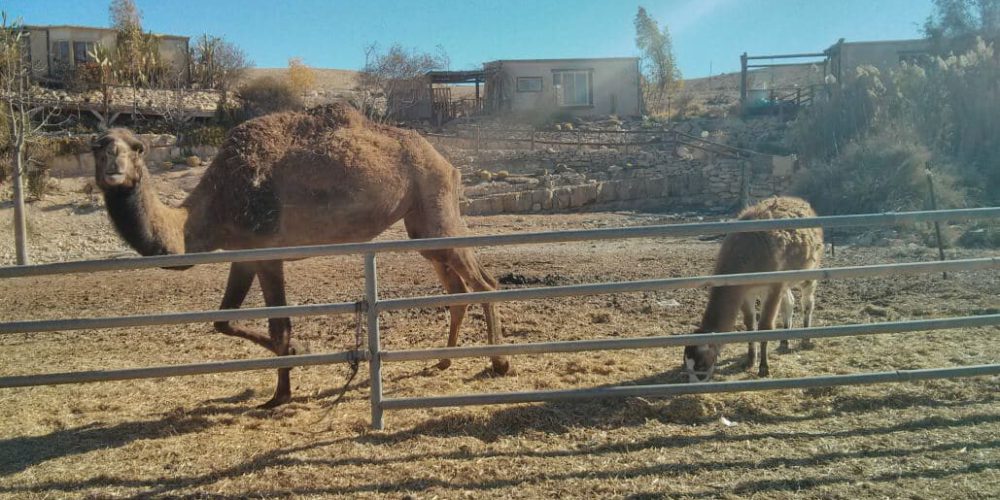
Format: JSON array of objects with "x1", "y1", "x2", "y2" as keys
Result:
[{"x1": 92, "y1": 128, "x2": 146, "y2": 191}]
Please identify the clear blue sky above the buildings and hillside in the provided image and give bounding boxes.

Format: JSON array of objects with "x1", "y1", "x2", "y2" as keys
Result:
[{"x1": 0, "y1": 0, "x2": 931, "y2": 78}]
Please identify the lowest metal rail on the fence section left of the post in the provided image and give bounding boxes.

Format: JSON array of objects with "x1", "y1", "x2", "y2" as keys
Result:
[{"x1": 0, "y1": 351, "x2": 367, "y2": 388}]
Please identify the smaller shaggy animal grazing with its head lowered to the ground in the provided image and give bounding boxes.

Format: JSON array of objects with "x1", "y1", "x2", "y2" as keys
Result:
[{"x1": 684, "y1": 197, "x2": 823, "y2": 382}]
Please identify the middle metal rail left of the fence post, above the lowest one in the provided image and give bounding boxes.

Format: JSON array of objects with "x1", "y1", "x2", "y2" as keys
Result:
[{"x1": 0, "y1": 302, "x2": 358, "y2": 335}]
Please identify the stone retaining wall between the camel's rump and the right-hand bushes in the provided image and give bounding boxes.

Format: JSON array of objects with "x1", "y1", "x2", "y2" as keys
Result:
[{"x1": 461, "y1": 146, "x2": 795, "y2": 215}]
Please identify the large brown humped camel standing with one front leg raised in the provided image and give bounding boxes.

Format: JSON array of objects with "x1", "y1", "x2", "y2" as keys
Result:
[{"x1": 93, "y1": 105, "x2": 510, "y2": 408}]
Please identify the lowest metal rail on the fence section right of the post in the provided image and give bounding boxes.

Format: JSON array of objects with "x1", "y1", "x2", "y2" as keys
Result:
[{"x1": 382, "y1": 364, "x2": 1000, "y2": 410}]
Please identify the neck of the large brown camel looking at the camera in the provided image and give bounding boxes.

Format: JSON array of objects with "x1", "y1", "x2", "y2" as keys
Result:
[{"x1": 104, "y1": 172, "x2": 188, "y2": 256}]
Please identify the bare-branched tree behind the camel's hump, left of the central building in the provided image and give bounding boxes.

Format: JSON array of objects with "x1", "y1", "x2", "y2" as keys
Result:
[{"x1": 358, "y1": 43, "x2": 450, "y2": 121}]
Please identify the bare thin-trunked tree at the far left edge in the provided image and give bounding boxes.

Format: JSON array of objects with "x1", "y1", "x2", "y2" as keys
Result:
[{"x1": 0, "y1": 13, "x2": 61, "y2": 265}]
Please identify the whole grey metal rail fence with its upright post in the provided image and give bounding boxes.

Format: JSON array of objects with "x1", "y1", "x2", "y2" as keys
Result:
[{"x1": 0, "y1": 207, "x2": 1000, "y2": 429}]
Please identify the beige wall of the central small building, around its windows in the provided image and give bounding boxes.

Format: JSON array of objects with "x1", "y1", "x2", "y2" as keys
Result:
[{"x1": 502, "y1": 58, "x2": 642, "y2": 116}]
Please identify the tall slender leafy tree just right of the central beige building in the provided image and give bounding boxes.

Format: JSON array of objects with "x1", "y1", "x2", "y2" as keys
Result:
[{"x1": 635, "y1": 7, "x2": 681, "y2": 113}]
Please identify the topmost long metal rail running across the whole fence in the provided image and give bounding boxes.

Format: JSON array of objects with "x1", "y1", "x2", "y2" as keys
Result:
[{"x1": 0, "y1": 207, "x2": 1000, "y2": 278}]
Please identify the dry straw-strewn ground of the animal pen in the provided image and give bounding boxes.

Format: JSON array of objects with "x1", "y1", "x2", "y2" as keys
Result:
[{"x1": 0, "y1": 198, "x2": 1000, "y2": 498}]
